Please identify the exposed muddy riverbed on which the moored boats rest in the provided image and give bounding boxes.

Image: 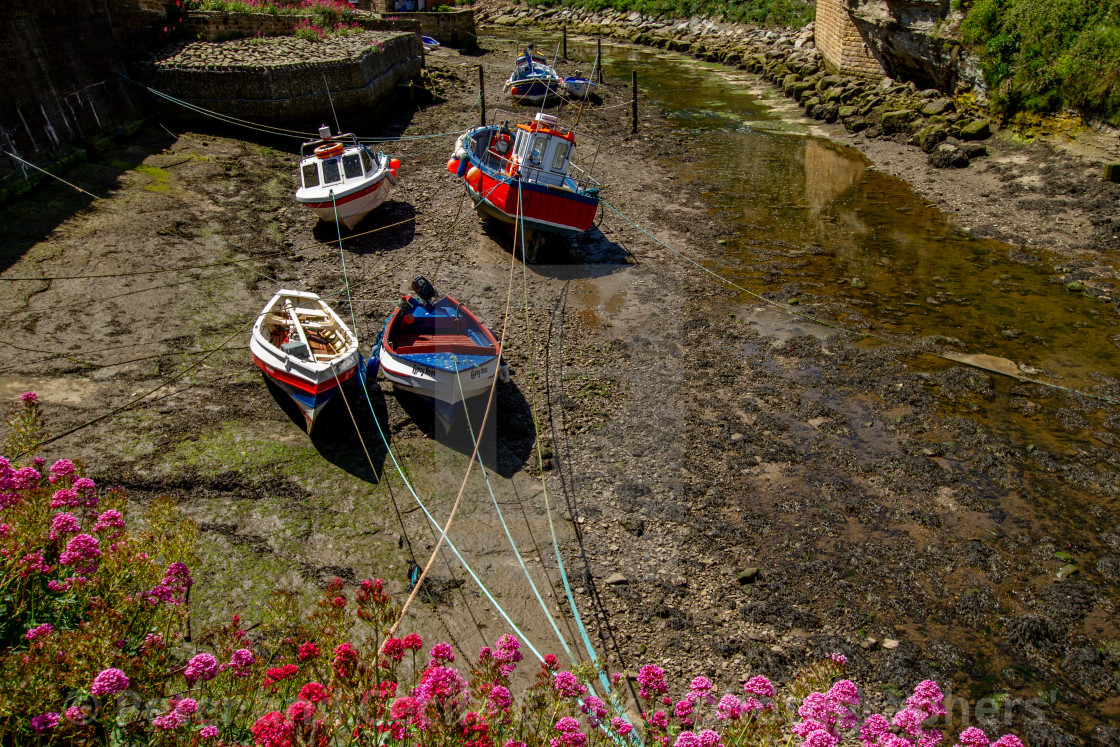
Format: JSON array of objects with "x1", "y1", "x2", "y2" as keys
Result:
[{"x1": 0, "y1": 32, "x2": 1120, "y2": 746}]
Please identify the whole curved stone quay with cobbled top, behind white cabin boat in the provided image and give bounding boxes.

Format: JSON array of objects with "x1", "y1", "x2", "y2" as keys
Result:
[{"x1": 136, "y1": 31, "x2": 422, "y2": 124}]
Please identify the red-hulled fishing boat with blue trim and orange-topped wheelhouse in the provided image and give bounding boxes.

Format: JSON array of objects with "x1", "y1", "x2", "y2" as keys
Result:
[{"x1": 447, "y1": 113, "x2": 599, "y2": 250}]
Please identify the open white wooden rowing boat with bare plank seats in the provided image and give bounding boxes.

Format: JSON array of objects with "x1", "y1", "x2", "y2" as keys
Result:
[{"x1": 249, "y1": 290, "x2": 360, "y2": 433}]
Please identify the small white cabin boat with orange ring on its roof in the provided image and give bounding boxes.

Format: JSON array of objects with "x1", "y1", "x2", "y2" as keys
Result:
[{"x1": 296, "y1": 125, "x2": 401, "y2": 228}]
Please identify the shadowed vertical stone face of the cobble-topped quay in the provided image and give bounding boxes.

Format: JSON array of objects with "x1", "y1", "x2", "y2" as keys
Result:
[{"x1": 136, "y1": 31, "x2": 422, "y2": 125}]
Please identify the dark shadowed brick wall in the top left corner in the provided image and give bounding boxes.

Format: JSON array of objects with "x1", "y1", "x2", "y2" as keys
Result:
[{"x1": 0, "y1": 0, "x2": 140, "y2": 178}]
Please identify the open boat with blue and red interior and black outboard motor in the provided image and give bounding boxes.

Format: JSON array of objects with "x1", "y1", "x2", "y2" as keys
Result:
[{"x1": 375, "y1": 276, "x2": 510, "y2": 423}]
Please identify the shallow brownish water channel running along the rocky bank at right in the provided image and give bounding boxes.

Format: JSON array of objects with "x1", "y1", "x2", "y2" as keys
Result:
[{"x1": 484, "y1": 30, "x2": 1120, "y2": 451}]
